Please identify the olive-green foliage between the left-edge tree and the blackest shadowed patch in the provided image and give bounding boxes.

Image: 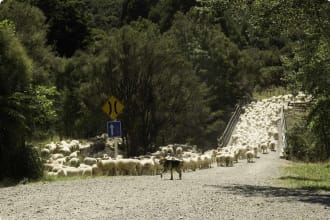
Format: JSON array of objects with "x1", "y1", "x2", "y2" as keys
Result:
[{"x1": 0, "y1": 0, "x2": 58, "y2": 85}]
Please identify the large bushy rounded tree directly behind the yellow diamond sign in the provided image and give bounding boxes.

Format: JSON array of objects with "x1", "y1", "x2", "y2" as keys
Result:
[{"x1": 61, "y1": 20, "x2": 209, "y2": 156}]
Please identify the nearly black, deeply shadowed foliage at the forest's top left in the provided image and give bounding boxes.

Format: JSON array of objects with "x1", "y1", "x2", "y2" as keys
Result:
[{"x1": 33, "y1": 0, "x2": 90, "y2": 57}]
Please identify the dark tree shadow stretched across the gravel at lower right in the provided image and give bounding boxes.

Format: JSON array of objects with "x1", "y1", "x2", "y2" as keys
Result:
[{"x1": 205, "y1": 185, "x2": 330, "y2": 207}]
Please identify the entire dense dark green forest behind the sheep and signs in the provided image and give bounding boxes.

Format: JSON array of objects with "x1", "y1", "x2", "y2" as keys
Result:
[{"x1": 0, "y1": 0, "x2": 330, "y2": 180}]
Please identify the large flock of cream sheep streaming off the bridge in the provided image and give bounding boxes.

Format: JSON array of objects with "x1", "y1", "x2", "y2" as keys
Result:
[{"x1": 41, "y1": 93, "x2": 310, "y2": 180}]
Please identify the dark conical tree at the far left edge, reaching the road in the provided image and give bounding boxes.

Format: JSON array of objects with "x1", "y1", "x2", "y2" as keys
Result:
[{"x1": 0, "y1": 20, "x2": 42, "y2": 180}]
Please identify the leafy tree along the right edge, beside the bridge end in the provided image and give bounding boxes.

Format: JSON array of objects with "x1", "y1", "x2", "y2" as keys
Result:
[{"x1": 278, "y1": 0, "x2": 330, "y2": 160}]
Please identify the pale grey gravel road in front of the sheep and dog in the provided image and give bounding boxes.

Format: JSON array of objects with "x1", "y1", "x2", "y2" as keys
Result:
[{"x1": 0, "y1": 152, "x2": 330, "y2": 220}]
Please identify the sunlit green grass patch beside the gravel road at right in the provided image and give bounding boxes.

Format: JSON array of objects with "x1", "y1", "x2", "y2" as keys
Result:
[{"x1": 280, "y1": 162, "x2": 330, "y2": 191}]
